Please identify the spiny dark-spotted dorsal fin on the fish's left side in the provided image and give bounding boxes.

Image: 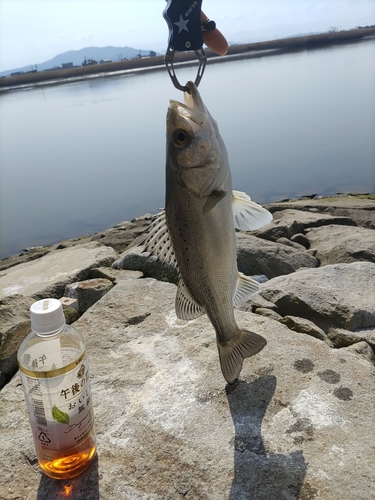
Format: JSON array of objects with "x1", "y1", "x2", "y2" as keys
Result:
[{"x1": 141, "y1": 210, "x2": 178, "y2": 268}]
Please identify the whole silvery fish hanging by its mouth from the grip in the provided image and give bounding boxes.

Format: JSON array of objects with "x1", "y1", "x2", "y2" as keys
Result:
[{"x1": 143, "y1": 82, "x2": 272, "y2": 384}]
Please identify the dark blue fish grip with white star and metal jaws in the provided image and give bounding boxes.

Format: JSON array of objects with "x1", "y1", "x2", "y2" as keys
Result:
[{"x1": 163, "y1": 0, "x2": 209, "y2": 92}]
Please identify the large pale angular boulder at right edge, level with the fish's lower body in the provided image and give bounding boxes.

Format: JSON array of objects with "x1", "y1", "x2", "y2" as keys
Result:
[{"x1": 260, "y1": 262, "x2": 375, "y2": 332}]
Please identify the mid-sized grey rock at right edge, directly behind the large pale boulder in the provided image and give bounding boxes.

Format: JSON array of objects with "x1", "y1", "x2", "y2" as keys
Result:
[{"x1": 306, "y1": 226, "x2": 375, "y2": 266}]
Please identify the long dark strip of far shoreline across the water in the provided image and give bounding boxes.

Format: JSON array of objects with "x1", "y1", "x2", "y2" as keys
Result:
[{"x1": 0, "y1": 26, "x2": 375, "y2": 92}]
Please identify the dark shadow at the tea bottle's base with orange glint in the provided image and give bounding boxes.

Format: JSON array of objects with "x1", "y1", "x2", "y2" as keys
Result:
[{"x1": 36, "y1": 456, "x2": 100, "y2": 500}]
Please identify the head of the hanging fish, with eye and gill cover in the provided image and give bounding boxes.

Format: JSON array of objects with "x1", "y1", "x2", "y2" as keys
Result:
[{"x1": 167, "y1": 82, "x2": 231, "y2": 198}]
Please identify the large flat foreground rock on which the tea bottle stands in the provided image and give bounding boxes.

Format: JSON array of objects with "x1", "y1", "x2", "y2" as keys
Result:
[{"x1": 0, "y1": 279, "x2": 375, "y2": 500}]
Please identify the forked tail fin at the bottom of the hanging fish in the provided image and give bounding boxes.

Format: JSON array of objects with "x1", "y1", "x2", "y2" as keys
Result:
[{"x1": 217, "y1": 330, "x2": 267, "y2": 384}]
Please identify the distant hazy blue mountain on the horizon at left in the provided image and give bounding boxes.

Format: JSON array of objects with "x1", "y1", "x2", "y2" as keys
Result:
[{"x1": 0, "y1": 47, "x2": 160, "y2": 76}]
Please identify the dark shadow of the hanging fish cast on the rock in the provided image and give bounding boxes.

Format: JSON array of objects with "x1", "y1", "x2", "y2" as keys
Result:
[{"x1": 226, "y1": 375, "x2": 307, "y2": 500}]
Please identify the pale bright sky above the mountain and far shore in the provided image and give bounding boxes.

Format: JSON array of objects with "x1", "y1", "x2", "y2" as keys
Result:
[{"x1": 0, "y1": 0, "x2": 375, "y2": 72}]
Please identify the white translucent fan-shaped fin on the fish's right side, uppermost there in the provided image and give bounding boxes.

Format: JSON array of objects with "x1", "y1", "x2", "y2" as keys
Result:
[{"x1": 233, "y1": 191, "x2": 272, "y2": 231}]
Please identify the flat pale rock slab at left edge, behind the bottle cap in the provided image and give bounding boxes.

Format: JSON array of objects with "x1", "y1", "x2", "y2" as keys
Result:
[{"x1": 0, "y1": 243, "x2": 118, "y2": 300}]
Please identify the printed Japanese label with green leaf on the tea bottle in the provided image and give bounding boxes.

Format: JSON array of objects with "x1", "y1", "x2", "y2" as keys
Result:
[{"x1": 21, "y1": 353, "x2": 94, "y2": 460}]
